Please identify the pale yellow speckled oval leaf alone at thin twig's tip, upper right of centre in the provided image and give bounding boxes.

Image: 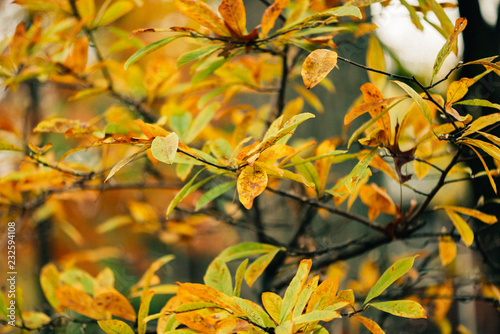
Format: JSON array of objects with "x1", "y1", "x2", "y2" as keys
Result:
[{"x1": 301, "y1": 49, "x2": 337, "y2": 89}]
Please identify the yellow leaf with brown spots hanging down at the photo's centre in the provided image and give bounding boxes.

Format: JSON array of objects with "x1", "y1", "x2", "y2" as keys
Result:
[{"x1": 236, "y1": 166, "x2": 267, "y2": 209}]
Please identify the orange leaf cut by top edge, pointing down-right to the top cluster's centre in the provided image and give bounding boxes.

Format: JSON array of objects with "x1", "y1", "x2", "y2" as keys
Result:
[{"x1": 174, "y1": 0, "x2": 230, "y2": 36}]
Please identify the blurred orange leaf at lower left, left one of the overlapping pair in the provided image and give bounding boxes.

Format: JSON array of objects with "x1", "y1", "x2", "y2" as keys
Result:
[{"x1": 56, "y1": 285, "x2": 104, "y2": 319}]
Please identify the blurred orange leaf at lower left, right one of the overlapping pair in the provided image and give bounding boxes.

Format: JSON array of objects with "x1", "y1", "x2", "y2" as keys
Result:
[{"x1": 93, "y1": 287, "x2": 137, "y2": 321}]
